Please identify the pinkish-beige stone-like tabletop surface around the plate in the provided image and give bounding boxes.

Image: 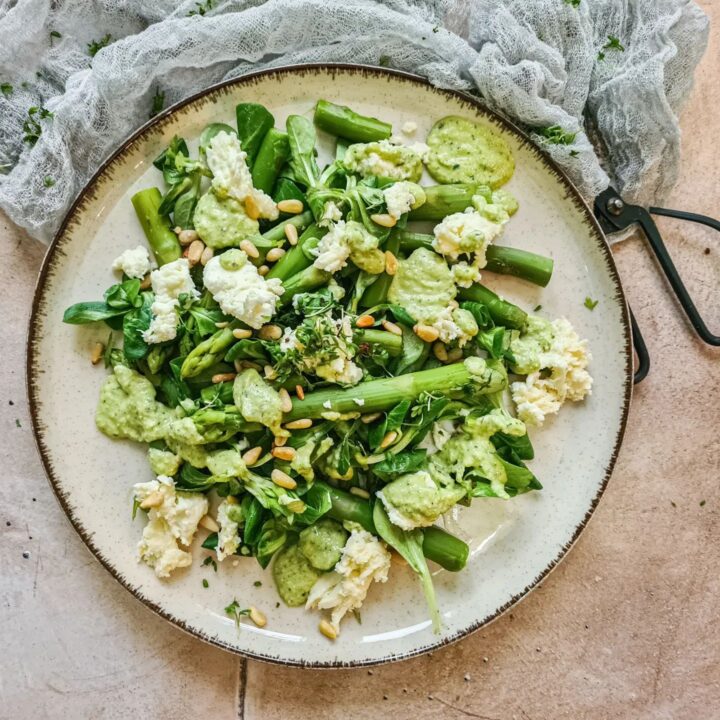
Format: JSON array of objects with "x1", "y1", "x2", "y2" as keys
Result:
[{"x1": 0, "y1": 0, "x2": 720, "y2": 720}]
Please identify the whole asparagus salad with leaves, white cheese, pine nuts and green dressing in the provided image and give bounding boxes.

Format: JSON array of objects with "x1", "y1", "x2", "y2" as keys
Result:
[{"x1": 64, "y1": 100, "x2": 592, "y2": 638}]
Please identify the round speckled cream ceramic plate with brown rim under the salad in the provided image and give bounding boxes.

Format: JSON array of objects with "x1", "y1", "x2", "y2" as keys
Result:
[{"x1": 28, "y1": 66, "x2": 632, "y2": 666}]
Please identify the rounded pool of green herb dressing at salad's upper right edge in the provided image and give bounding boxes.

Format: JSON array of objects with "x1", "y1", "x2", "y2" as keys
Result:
[{"x1": 427, "y1": 115, "x2": 515, "y2": 188}]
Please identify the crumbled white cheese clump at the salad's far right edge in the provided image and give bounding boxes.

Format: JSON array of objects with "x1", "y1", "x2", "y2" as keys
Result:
[{"x1": 510, "y1": 318, "x2": 593, "y2": 425}]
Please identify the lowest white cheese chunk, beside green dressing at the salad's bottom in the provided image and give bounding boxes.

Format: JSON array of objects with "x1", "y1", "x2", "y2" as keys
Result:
[{"x1": 305, "y1": 526, "x2": 390, "y2": 632}]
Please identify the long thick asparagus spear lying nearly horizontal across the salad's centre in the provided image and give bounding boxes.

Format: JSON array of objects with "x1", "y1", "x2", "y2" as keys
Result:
[{"x1": 284, "y1": 358, "x2": 507, "y2": 422}]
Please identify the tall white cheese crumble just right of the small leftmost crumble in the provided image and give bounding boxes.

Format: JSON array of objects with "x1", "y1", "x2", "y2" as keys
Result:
[{"x1": 143, "y1": 258, "x2": 200, "y2": 344}]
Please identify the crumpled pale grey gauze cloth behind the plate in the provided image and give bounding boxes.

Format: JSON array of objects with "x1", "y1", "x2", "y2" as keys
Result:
[{"x1": 0, "y1": 0, "x2": 708, "y2": 242}]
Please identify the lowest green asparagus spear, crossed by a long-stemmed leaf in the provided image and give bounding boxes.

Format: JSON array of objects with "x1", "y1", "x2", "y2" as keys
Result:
[{"x1": 328, "y1": 485, "x2": 470, "y2": 572}]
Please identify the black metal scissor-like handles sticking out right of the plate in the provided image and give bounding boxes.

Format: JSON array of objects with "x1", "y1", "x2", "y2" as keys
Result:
[{"x1": 595, "y1": 188, "x2": 720, "y2": 384}]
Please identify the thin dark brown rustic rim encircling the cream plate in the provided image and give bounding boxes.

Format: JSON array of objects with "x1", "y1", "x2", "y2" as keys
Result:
[{"x1": 26, "y1": 63, "x2": 634, "y2": 669}]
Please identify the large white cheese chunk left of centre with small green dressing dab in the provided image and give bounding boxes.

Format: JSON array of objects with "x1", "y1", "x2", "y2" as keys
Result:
[{"x1": 203, "y1": 255, "x2": 284, "y2": 330}]
